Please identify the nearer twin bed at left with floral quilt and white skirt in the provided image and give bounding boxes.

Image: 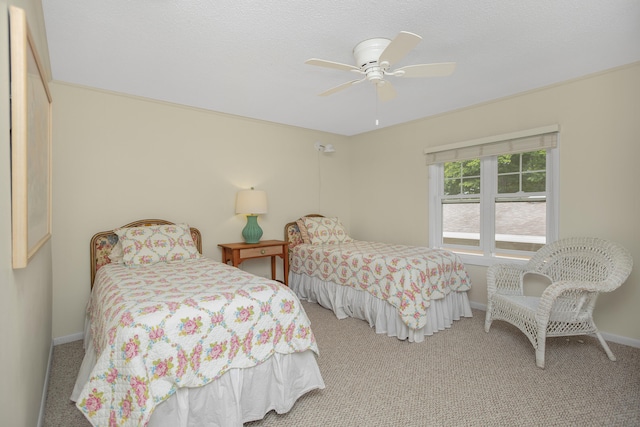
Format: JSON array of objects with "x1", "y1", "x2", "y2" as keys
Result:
[{"x1": 71, "y1": 220, "x2": 324, "y2": 426}]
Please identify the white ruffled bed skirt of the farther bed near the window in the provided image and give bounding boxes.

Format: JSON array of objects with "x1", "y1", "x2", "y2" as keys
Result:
[{"x1": 289, "y1": 272, "x2": 472, "y2": 342}]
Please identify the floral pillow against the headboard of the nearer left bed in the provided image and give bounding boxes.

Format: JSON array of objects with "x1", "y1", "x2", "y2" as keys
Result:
[{"x1": 114, "y1": 224, "x2": 200, "y2": 266}]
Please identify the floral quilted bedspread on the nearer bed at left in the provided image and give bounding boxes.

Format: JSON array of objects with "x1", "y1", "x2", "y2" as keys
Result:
[{"x1": 76, "y1": 258, "x2": 318, "y2": 426}]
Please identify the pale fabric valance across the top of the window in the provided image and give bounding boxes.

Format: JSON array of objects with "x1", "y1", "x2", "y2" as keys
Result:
[{"x1": 424, "y1": 125, "x2": 560, "y2": 165}]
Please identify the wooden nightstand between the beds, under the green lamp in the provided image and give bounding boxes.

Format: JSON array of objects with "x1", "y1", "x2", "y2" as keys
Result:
[{"x1": 218, "y1": 240, "x2": 289, "y2": 286}]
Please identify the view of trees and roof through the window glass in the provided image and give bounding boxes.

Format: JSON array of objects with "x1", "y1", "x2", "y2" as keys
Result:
[{"x1": 442, "y1": 150, "x2": 546, "y2": 251}]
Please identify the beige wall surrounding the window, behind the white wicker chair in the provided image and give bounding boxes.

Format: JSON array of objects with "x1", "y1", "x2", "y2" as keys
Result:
[{"x1": 349, "y1": 64, "x2": 640, "y2": 344}]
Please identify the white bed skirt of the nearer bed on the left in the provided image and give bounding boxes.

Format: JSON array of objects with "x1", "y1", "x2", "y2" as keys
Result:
[{"x1": 71, "y1": 322, "x2": 325, "y2": 427}]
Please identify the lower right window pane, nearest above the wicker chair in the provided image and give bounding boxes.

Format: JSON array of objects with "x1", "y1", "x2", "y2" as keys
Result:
[{"x1": 495, "y1": 200, "x2": 547, "y2": 252}]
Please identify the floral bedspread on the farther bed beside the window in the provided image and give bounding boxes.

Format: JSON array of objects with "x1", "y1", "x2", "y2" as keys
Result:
[{"x1": 290, "y1": 241, "x2": 471, "y2": 329}]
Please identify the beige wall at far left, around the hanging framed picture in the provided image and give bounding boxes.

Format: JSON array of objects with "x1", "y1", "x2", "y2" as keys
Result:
[{"x1": 0, "y1": 0, "x2": 52, "y2": 427}]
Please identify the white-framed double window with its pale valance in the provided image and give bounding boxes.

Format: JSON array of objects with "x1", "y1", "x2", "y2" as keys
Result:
[{"x1": 426, "y1": 127, "x2": 557, "y2": 265}]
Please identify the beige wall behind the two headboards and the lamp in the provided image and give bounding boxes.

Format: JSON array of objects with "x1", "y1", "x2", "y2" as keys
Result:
[{"x1": 52, "y1": 83, "x2": 350, "y2": 337}]
